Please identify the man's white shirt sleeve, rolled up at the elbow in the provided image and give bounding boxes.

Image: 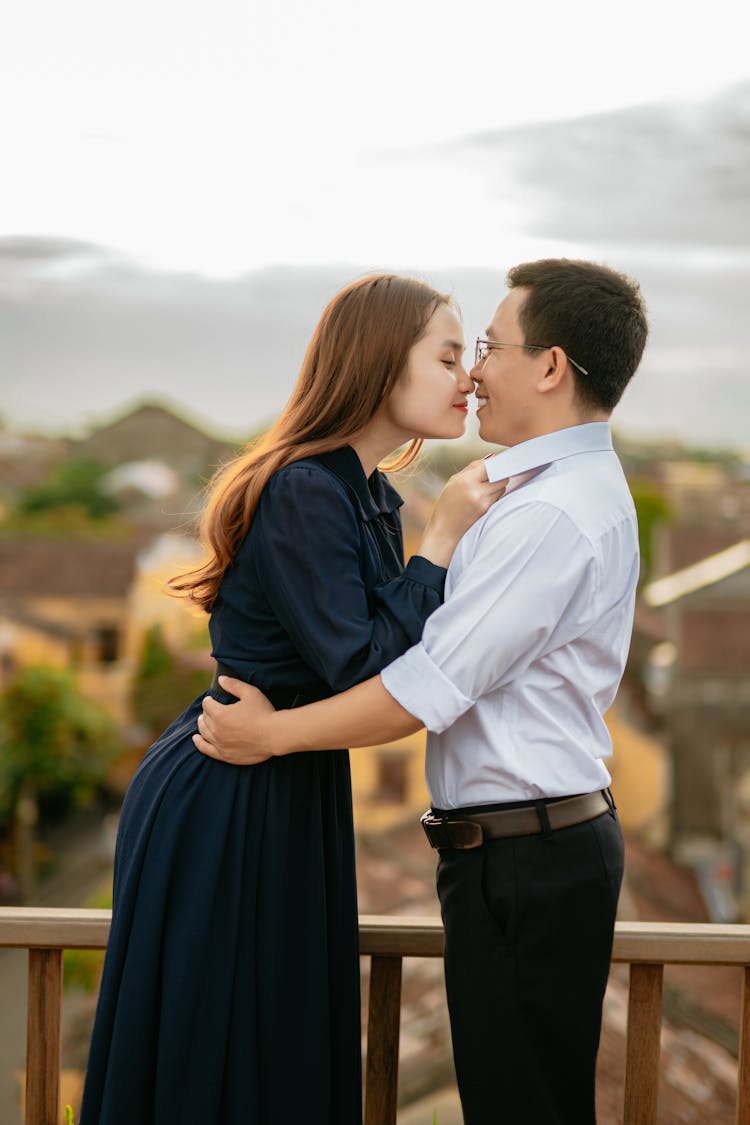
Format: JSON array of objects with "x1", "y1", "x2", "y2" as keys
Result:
[{"x1": 381, "y1": 502, "x2": 598, "y2": 732}]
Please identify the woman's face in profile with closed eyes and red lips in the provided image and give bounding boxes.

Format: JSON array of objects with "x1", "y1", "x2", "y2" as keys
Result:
[{"x1": 383, "y1": 305, "x2": 473, "y2": 438}]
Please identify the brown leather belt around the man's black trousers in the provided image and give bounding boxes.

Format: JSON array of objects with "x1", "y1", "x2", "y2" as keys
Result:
[{"x1": 422, "y1": 790, "x2": 615, "y2": 851}]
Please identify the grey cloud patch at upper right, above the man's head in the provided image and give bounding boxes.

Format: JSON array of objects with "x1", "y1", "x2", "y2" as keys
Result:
[{"x1": 462, "y1": 83, "x2": 750, "y2": 250}]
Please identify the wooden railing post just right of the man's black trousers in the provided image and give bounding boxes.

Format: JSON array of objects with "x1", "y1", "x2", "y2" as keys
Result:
[{"x1": 623, "y1": 964, "x2": 665, "y2": 1125}]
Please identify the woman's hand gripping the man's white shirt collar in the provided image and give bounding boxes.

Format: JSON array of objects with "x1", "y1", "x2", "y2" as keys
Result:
[{"x1": 417, "y1": 460, "x2": 508, "y2": 566}]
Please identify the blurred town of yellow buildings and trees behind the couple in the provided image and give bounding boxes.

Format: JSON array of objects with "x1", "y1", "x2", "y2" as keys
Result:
[{"x1": 0, "y1": 402, "x2": 750, "y2": 1125}]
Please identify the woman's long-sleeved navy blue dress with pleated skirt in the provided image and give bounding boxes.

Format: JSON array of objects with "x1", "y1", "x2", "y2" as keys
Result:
[{"x1": 80, "y1": 447, "x2": 445, "y2": 1125}]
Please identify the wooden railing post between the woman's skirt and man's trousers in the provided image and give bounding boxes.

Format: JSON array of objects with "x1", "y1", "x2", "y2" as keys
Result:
[{"x1": 364, "y1": 956, "x2": 401, "y2": 1125}]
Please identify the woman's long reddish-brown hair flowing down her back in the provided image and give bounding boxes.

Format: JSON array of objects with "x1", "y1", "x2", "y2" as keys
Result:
[{"x1": 168, "y1": 273, "x2": 451, "y2": 612}]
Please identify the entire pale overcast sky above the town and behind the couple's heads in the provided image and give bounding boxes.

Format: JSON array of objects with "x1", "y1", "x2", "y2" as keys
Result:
[{"x1": 0, "y1": 0, "x2": 750, "y2": 448}]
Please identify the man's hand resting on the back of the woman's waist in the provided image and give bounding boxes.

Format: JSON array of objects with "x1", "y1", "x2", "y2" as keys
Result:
[{"x1": 192, "y1": 676, "x2": 275, "y2": 766}]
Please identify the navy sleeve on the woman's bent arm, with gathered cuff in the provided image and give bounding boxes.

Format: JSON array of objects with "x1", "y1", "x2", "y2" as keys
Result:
[{"x1": 253, "y1": 465, "x2": 445, "y2": 692}]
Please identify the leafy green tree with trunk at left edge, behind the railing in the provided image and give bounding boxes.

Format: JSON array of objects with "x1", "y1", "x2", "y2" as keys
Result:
[{"x1": 0, "y1": 667, "x2": 121, "y2": 897}]
